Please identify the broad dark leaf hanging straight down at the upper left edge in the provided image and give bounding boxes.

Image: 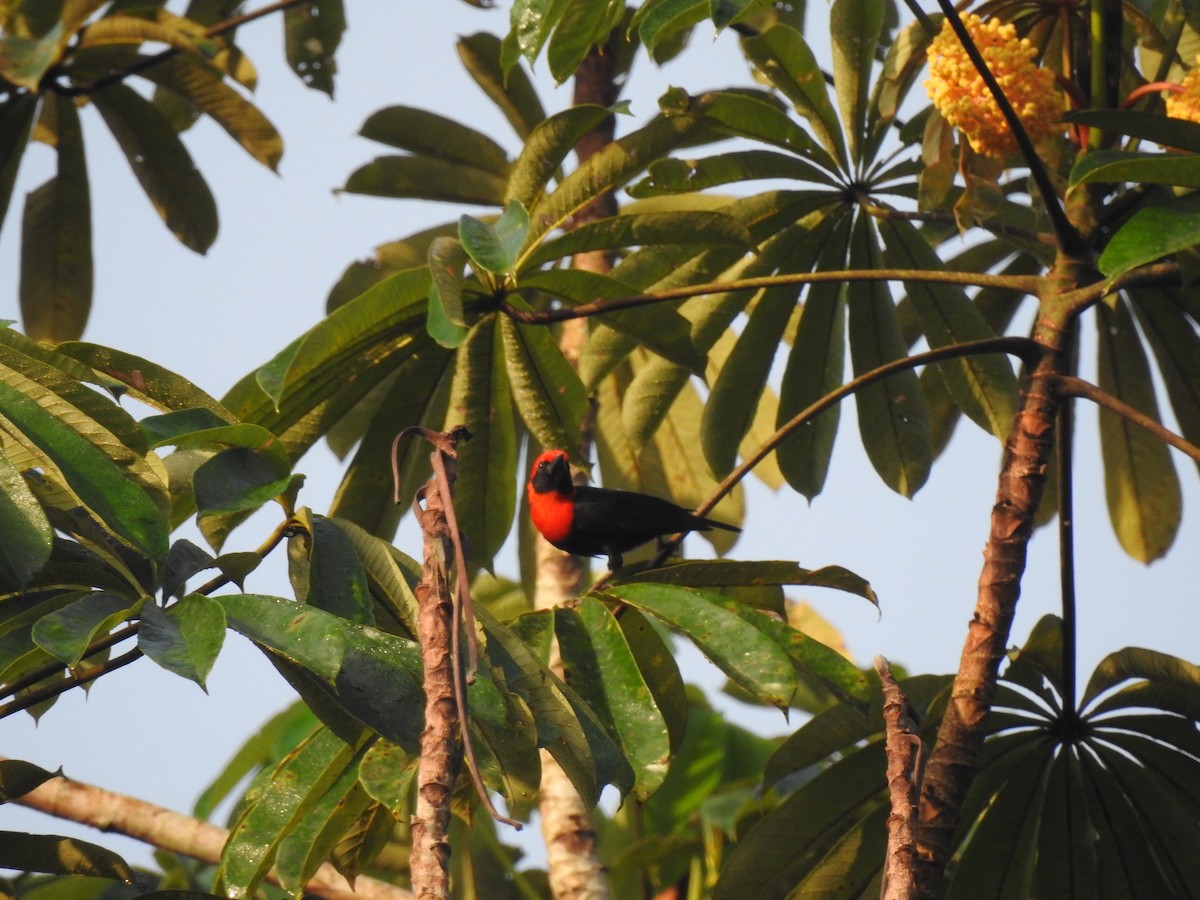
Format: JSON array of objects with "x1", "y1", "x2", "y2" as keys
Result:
[{"x1": 20, "y1": 93, "x2": 92, "y2": 342}]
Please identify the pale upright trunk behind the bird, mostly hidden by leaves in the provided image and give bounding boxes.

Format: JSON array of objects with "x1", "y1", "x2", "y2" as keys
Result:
[{"x1": 534, "y1": 35, "x2": 617, "y2": 900}]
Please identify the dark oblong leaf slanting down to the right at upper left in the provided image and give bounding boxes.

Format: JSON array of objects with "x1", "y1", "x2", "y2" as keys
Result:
[{"x1": 90, "y1": 84, "x2": 217, "y2": 253}]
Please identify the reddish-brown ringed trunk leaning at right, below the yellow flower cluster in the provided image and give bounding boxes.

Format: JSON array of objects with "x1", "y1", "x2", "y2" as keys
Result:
[{"x1": 917, "y1": 328, "x2": 1066, "y2": 898}]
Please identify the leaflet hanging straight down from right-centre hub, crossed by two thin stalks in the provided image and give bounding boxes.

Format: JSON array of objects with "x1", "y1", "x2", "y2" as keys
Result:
[{"x1": 846, "y1": 215, "x2": 934, "y2": 497}]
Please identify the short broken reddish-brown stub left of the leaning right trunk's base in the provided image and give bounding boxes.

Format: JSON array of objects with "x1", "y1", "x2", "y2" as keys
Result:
[{"x1": 875, "y1": 656, "x2": 924, "y2": 900}]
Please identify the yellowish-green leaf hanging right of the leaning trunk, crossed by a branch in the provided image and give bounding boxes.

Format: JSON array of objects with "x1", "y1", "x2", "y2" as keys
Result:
[{"x1": 1097, "y1": 301, "x2": 1183, "y2": 563}]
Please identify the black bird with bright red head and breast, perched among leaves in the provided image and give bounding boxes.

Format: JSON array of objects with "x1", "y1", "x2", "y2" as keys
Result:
[{"x1": 526, "y1": 450, "x2": 742, "y2": 571}]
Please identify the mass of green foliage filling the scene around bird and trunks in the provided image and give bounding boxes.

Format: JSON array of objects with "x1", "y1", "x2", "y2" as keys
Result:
[{"x1": 7, "y1": 0, "x2": 1200, "y2": 898}]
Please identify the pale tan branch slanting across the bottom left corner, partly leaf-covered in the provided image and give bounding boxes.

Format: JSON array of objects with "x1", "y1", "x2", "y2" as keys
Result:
[{"x1": 14, "y1": 758, "x2": 413, "y2": 900}]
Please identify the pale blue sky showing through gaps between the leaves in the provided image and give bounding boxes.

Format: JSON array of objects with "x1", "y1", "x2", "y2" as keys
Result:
[{"x1": 0, "y1": 0, "x2": 1200, "y2": 864}]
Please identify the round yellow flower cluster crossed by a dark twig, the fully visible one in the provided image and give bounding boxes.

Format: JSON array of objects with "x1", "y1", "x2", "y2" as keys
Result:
[{"x1": 925, "y1": 13, "x2": 1064, "y2": 158}]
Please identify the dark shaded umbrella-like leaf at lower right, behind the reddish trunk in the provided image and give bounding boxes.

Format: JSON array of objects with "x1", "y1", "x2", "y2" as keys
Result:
[{"x1": 716, "y1": 617, "x2": 1200, "y2": 899}]
